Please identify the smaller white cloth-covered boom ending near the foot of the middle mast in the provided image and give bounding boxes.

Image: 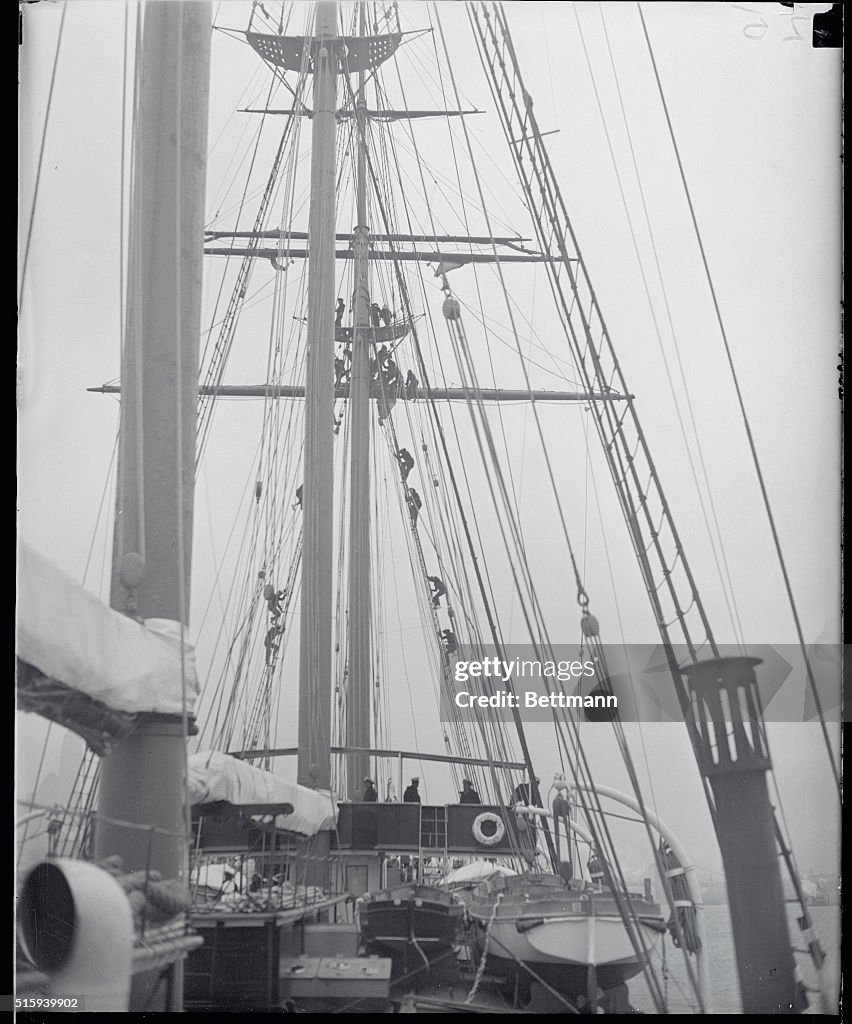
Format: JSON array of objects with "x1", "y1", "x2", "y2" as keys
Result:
[{"x1": 189, "y1": 751, "x2": 337, "y2": 836}]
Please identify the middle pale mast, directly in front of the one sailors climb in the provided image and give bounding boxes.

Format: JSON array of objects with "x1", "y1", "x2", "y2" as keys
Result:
[{"x1": 294, "y1": 0, "x2": 337, "y2": 788}]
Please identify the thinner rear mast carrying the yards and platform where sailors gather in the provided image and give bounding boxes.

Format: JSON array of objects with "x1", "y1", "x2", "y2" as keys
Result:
[{"x1": 346, "y1": 3, "x2": 371, "y2": 799}]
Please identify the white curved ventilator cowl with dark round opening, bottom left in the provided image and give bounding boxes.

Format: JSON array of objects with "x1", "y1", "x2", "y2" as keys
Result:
[{"x1": 18, "y1": 858, "x2": 134, "y2": 1013}]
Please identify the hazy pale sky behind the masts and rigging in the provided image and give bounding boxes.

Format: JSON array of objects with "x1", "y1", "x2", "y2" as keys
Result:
[{"x1": 17, "y1": 0, "x2": 841, "y2": 869}]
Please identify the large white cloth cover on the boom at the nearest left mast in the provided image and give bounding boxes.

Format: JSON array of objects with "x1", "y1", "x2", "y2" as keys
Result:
[{"x1": 16, "y1": 543, "x2": 199, "y2": 715}]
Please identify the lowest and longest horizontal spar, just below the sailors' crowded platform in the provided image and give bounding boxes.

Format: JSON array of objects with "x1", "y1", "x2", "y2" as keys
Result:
[{"x1": 87, "y1": 384, "x2": 634, "y2": 401}]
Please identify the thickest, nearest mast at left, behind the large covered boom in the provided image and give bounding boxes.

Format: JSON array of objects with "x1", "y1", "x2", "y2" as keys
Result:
[{"x1": 95, "y1": 2, "x2": 211, "y2": 878}]
